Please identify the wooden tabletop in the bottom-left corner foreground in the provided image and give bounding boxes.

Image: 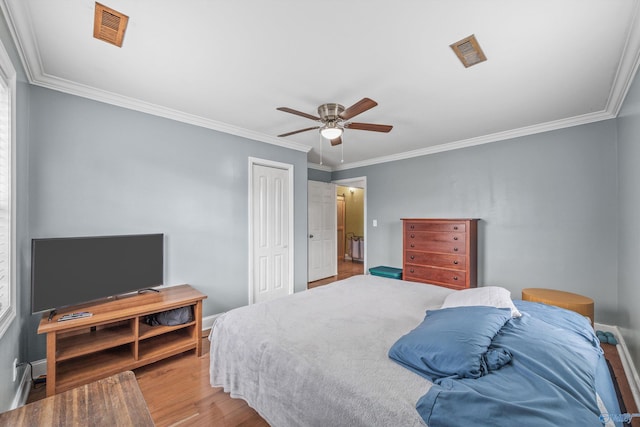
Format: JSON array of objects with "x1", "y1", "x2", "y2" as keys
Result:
[{"x1": 0, "y1": 371, "x2": 154, "y2": 427}]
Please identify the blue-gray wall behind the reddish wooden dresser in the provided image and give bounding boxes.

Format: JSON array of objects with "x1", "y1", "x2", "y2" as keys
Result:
[{"x1": 332, "y1": 120, "x2": 618, "y2": 324}]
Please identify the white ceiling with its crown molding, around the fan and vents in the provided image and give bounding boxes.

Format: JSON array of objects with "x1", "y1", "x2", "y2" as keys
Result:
[{"x1": 0, "y1": 0, "x2": 640, "y2": 170}]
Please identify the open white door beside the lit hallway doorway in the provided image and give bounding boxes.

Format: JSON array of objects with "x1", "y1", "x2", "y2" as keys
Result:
[{"x1": 307, "y1": 181, "x2": 338, "y2": 282}]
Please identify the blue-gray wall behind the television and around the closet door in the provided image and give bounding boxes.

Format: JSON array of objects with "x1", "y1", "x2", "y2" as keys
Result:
[{"x1": 26, "y1": 86, "x2": 307, "y2": 360}]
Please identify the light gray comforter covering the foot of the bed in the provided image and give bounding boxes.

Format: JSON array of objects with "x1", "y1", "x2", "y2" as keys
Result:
[{"x1": 210, "y1": 276, "x2": 452, "y2": 427}]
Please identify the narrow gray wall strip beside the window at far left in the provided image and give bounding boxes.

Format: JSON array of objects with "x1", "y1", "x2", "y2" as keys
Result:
[{"x1": 0, "y1": 7, "x2": 31, "y2": 412}]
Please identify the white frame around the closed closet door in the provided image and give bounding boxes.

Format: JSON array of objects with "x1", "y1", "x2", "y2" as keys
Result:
[{"x1": 247, "y1": 157, "x2": 295, "y2": 305}]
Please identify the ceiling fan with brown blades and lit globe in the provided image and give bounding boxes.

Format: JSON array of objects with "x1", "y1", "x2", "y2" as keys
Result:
[{"x1": 277, "y1": 98, "x2": 393, "y2": 145}]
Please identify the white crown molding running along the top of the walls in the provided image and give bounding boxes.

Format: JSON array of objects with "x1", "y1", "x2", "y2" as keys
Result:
[{"x1": 0, "y1": 0, "x2": 640, "y2": 172}]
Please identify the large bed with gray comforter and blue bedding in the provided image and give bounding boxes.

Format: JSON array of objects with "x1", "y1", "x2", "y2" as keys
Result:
[{"x1": 209, "y1": 275, "x2": 619, "y2": 427}]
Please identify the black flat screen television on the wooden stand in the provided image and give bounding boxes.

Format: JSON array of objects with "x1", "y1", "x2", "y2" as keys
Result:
[{"x1": 31, "y1": 234, "x2": 164, "y2": 313}]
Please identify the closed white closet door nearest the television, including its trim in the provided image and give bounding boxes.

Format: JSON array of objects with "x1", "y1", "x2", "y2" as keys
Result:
[{"x1": 250, "y1": 164, "x2": 293, "y2": 302}]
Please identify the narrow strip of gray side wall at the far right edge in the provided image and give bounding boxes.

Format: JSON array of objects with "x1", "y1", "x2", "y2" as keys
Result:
[{"x1": 617, "y1": 73, "x2": 640, "y2": 367}]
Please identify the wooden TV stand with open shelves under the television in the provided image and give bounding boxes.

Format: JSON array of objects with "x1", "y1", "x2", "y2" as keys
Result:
[{"x1": 38, "y1": 285, "x2": 207, "y2": 396}]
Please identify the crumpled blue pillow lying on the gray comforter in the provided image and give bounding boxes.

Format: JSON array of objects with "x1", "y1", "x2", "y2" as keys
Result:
[{"x1": 389, "y1": 306, "x2": 511, "y2": 381}]
